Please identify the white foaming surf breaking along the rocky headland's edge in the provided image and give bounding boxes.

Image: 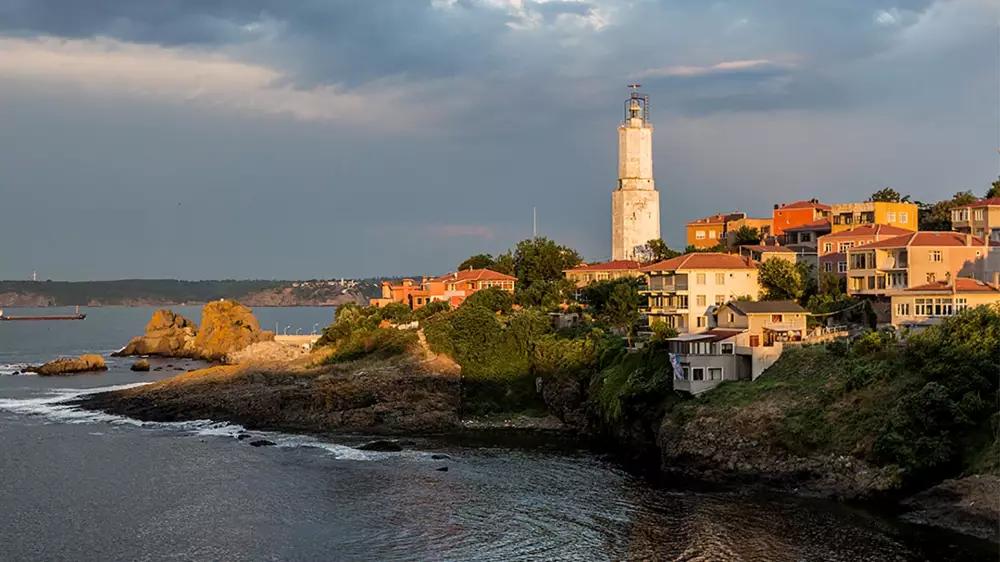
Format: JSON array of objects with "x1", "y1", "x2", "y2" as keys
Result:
[{"x1": 0, "y1": 382, "x2": 406, "y2": 461}]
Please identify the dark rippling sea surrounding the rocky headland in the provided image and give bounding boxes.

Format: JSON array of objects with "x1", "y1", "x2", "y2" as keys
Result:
[{"x1": 0, "y1": 307, "x2": 997, "y2": 562}]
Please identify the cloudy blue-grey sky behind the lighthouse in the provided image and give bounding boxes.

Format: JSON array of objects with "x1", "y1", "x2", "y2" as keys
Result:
[{"x1": 0, "y1": 0, "x2": 1000, "y2": 280}]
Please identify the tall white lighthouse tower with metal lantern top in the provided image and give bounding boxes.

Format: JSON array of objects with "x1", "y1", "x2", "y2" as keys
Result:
[{"x1": 611, "y1": 84, "x2": 660, "y2": 260}]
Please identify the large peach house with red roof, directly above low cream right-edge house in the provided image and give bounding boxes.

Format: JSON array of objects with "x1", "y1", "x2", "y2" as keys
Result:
[{"x1": 847, "y1": 231, "x2": 1000, "y2": 297}]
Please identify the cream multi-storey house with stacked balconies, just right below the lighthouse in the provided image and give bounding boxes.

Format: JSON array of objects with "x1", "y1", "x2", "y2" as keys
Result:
[{"x1": 640, "y1": 252, "x2": 760, "y2": 332}]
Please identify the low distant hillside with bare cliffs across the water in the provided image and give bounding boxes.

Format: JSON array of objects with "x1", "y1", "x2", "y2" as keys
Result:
[{"x1": 0, "y1": 279, "x2": 378, "y2": 307}]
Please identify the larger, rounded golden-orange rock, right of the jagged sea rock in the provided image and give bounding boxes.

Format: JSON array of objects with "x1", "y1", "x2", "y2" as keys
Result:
[{"x1": 194, "y1": 300, "x2": 274, "y2": 361}]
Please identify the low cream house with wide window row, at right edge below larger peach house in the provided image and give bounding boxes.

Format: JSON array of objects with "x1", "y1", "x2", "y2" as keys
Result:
[{"x1": 890, "y1": 274, "x2": 1000, "y2": 329}]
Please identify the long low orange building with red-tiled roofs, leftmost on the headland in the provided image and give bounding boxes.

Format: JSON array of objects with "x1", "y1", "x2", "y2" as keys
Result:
[{"x1": 369, "y1": 269, "x2": 517, "y2": 310}]
